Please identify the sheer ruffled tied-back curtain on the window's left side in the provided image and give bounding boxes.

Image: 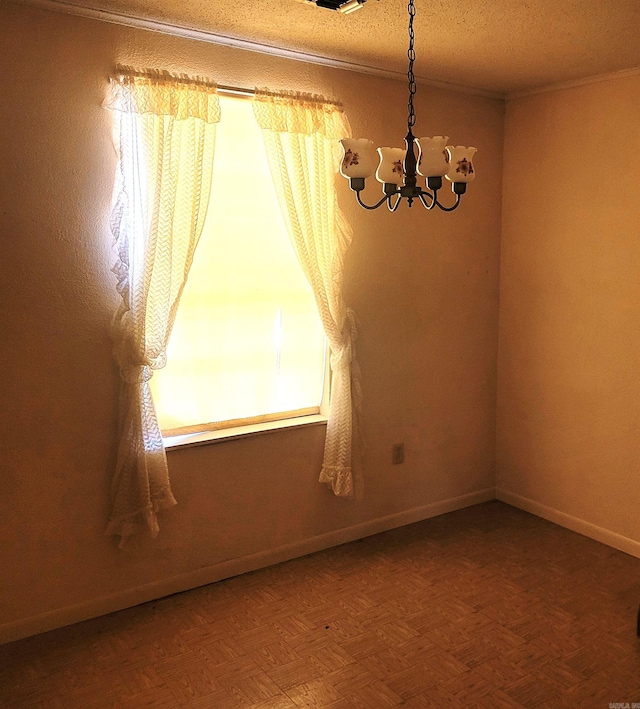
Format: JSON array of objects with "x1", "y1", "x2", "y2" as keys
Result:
[{"x1": 106, "y1": 69, "x2": 220, "y2": 546}]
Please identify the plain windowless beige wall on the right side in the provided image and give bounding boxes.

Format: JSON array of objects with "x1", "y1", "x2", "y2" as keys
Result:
[{"x1": 497, "y1": 75, "x2": 640, "y2": 554}]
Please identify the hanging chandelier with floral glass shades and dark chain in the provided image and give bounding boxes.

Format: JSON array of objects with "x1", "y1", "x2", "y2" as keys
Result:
[{"x1": 340, "y1": 0, "x2": 476, "y2": 212}]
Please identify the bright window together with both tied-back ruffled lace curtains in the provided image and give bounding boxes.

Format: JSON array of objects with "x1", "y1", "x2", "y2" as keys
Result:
[{"x1": 107, "y1": 73, "x2": 360, "y2": 541}]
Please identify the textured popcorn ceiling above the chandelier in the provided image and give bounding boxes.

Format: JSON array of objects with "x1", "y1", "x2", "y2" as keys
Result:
[{"x1": 45, "y1": 0, "x2": 640, "y2": 94}]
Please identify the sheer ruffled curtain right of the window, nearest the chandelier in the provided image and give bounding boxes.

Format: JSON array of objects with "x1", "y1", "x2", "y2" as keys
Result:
[{"x1": 253, "y1": 90, "x2": 361, "y2": 496}]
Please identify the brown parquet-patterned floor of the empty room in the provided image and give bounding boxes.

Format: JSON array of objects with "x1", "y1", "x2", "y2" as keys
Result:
[{"x1": 0, "y1": 502, "x2": 640, "y2": 709}]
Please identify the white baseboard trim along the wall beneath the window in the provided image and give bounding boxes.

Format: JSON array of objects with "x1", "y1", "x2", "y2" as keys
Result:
[{"x1": 0, "y1": 488, "x2": 495, "y2": 644}]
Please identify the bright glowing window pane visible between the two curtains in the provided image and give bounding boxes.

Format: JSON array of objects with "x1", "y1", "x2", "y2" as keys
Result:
[{"x1": 151, "y1": 97, "x2": 326, "y2": 435}]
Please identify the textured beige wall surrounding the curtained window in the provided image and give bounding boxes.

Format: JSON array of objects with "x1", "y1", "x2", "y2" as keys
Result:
[{"x1": 0, "y1": 3, "x2": 504, "y2": 639}]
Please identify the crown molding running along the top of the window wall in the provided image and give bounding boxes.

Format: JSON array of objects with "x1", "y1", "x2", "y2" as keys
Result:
[{"x1": 11, "y1": 0, "x2": 505, "y2": 100}]
